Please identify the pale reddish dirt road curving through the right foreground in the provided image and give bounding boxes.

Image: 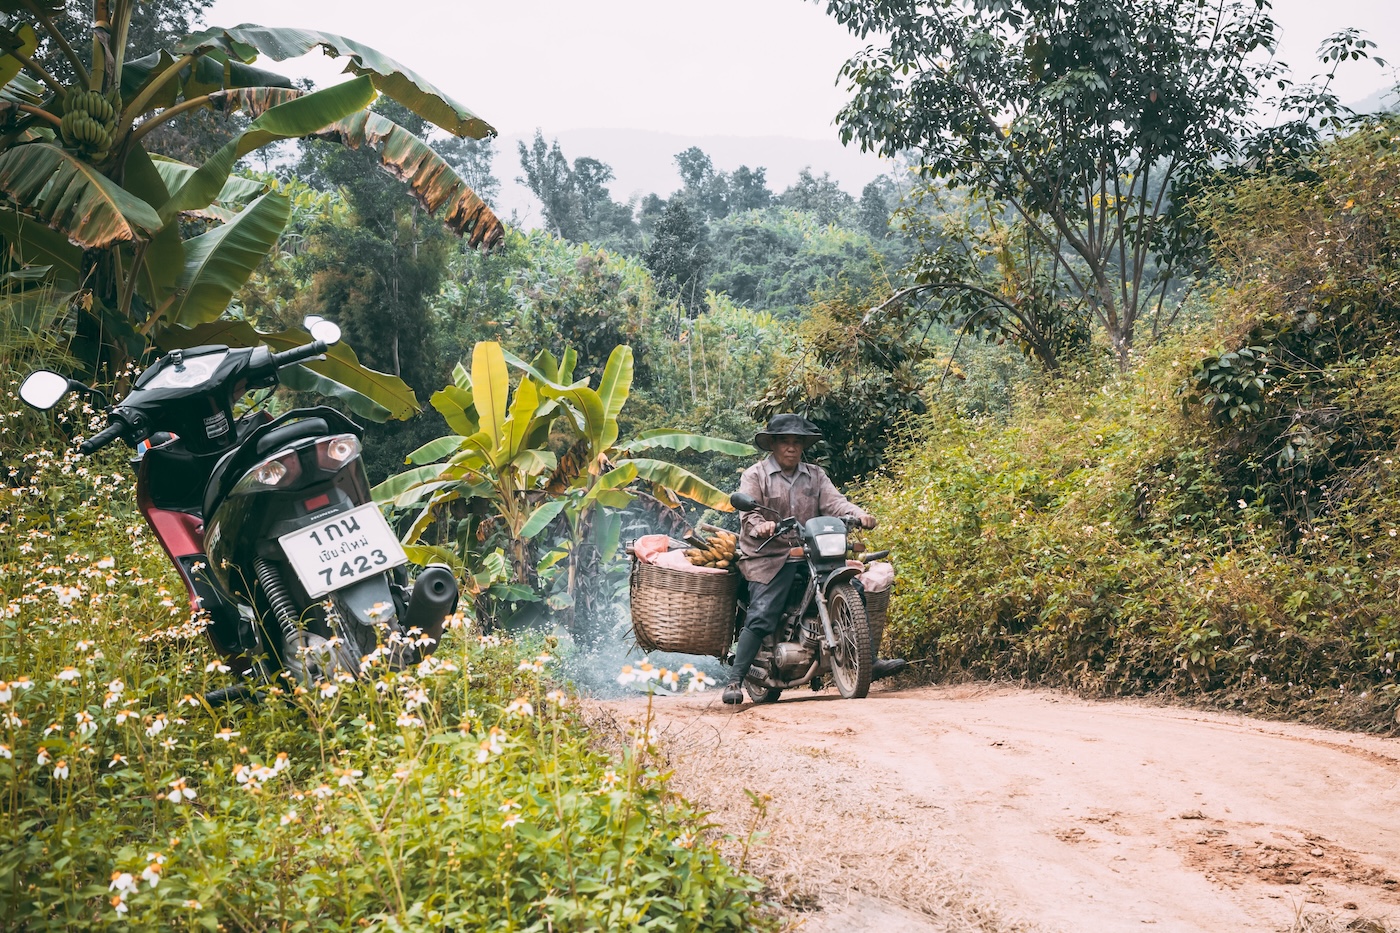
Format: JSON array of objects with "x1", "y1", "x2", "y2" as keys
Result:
[{"x1": 624, "y1": 686, "x2": 1400, "y2": 933}]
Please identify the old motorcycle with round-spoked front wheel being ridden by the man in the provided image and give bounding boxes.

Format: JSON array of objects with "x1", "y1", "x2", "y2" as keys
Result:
[{"x1": 729, "y1": 493, "x2": 889, "y2": 703}]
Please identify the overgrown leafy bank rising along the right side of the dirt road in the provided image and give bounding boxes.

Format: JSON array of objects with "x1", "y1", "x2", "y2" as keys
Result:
[{"x1": 865, "y1": 120, "x2": 1400, "y2": 728}]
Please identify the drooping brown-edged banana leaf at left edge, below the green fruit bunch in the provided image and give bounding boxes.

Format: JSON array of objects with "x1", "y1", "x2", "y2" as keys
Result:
[{"x1": 0, "y1": 143, "x2": 164, "y2": 249}]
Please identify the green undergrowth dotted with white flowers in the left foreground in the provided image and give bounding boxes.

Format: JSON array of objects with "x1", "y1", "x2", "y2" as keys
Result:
[{"x1": 0, "y1": 372, "x2": 762, "y2": 930}]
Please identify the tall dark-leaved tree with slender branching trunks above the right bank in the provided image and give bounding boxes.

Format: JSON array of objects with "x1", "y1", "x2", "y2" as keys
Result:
[{"x1": 827, "y1": 0, "x2": 1369, "y2": 366}]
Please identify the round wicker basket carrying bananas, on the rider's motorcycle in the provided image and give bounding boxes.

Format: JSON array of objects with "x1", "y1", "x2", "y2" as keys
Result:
[{"x1": 631, "y1": 560, "x2": 739, "y2": 657}]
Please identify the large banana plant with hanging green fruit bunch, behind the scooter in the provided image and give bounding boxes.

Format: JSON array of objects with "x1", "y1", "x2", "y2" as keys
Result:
[{"x1": 0, "y1": 0, "x2": 504, "y2": 417}]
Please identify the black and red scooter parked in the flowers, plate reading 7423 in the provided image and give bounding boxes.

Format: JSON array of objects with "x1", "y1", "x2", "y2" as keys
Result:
[{"x1": 20, "y1": 318, "x2": 458, "y2": 703}]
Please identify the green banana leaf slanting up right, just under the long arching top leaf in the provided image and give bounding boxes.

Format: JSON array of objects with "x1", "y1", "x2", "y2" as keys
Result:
[{"x1": 161, "y1": 78, "x2": 374, "y2": 223}]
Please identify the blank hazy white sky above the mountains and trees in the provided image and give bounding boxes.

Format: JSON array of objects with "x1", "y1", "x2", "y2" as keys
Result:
[{"x1": 206, "y1": 0, "x2": 1400, "y2": 139}]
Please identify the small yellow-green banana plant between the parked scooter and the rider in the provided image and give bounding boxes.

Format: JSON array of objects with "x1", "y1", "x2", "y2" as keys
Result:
[{"x1": 374, "y1": 342, "x2": 755, "y2": 622}]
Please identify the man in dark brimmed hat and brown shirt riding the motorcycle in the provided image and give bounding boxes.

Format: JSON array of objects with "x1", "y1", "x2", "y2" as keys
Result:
[{"x1": 722, "y1": 415, "x2": 907, "y2": 705}]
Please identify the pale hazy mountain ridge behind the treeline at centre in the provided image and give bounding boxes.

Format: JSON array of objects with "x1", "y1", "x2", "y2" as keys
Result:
[{"x1": 491, "y1": 127, "x2": 895, "y2": 228}]
